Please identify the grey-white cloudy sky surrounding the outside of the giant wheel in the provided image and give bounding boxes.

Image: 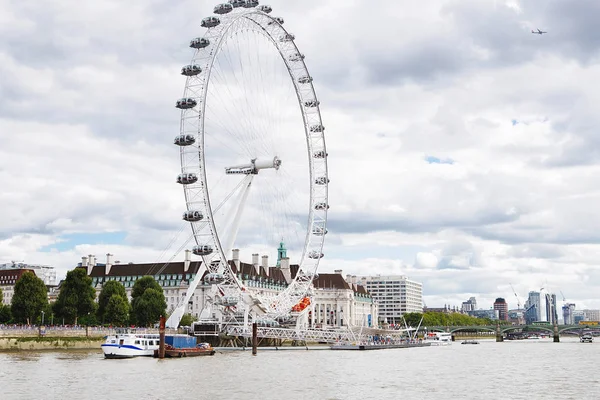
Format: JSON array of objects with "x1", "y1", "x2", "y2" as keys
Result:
[{"x1": 0, "y1": 0, "x2": 600, "y2": 308}]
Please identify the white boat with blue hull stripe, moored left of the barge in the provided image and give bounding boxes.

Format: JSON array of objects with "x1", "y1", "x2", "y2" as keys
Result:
[{"x1": 102, "y1": 328, "x2": 160, "y2": 358}]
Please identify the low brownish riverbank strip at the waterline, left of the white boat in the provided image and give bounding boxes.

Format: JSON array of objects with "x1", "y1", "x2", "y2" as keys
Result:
[{"x1": 0, "y1": 336, "x2": 104, "y2": 352}]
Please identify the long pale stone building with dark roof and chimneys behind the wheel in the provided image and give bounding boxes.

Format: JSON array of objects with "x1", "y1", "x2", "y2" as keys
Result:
[{"x1": 78, "y1": 243, "x2": 378, "y2": 328}]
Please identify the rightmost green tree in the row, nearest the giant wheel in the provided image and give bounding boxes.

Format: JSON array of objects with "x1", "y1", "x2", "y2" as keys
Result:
[{"x1": 131, "y1": 276, "x2": 167, "y2": 326}]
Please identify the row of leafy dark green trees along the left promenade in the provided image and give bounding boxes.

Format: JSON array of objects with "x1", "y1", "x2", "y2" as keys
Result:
[{"x1": 0, "y1": 268, "x2": 191, "y2": 326}]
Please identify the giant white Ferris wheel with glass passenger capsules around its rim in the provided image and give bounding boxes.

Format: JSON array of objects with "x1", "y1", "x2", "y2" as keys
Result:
[{"x1": 169, "y1": 0, "x2": 329, "y2": 324}]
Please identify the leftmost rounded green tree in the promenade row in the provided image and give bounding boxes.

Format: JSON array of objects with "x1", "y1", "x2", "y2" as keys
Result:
[{"x1": 11, "y1": 271, "x2": 48, "y2": 324}]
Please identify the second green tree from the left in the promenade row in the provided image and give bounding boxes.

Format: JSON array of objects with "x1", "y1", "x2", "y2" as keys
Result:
[{"x1": 54, "y1": 268, "x2": 96, "y2": 324}]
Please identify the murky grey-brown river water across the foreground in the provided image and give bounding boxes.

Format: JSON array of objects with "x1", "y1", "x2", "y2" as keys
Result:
[{"x1": 0, "y1": 338, "x2": 600, "y2": 400}]
